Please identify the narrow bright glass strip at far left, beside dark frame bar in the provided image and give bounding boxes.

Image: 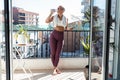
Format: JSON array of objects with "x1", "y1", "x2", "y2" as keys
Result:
[{"x1": 0, "y1": 0, "x2": 6, "y2": 80}]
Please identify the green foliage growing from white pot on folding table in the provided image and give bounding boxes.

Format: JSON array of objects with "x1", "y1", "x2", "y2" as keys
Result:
[{"x1": 14, "y1": 25, "x2": 30, "y2": 40}]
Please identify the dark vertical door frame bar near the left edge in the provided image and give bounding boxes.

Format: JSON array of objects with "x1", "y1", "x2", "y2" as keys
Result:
[{"x1": 4, "y1": 0, "x2": 11, "y2": 80}]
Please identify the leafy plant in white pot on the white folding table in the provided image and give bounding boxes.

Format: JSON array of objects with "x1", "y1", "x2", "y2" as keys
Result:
[{"x1": 14, "y1": 25, "x2": 30, "y2": 44}]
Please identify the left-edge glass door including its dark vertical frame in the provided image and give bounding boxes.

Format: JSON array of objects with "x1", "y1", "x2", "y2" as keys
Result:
[{"x1": 0, "y1": 0, "x2": 11, "y2": 80}]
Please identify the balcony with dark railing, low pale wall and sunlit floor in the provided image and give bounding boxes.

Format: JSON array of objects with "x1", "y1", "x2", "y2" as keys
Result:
[{"x1": 1, "y1": 30, "x2": 102, "y2": 80}]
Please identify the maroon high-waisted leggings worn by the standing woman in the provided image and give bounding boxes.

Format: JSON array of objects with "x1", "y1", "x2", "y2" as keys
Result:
[{"x1": 50, "y1": 30, "x2": 64, "y2": 67}]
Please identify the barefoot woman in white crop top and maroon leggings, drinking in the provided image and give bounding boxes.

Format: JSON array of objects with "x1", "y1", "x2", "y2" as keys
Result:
[{"x1": 46, "y1": 6, "x2": 71, "y2": 75}]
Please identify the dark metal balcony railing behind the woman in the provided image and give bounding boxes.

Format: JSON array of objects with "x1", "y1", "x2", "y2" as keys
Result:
[{"x1": 1, "y1": 30, "x2": 103, "y2": 58}]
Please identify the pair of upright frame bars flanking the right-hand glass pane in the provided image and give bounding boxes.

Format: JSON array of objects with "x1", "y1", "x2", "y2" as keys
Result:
[{"x1": 89, "y1": 0, "x2": 111, "y2": 80}]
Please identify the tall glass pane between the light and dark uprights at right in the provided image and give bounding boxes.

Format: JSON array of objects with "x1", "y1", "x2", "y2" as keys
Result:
[{"x1": 91, "y1": 0, "x2": 106, "y2": 80}]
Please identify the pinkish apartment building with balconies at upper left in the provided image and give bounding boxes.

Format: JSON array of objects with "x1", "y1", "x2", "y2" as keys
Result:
[{"x1": 13, "y1": 7, "x2": 39, "y2": 26}]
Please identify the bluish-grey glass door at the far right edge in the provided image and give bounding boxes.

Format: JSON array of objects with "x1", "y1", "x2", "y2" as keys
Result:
[{"x1": 108, "y1": 0, "x2": 120, "y2": 80}]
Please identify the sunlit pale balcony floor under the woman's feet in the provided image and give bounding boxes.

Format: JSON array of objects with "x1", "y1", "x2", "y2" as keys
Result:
[{"x1": 2, "y1": 69, "x2": 101, "y2": 80}]
